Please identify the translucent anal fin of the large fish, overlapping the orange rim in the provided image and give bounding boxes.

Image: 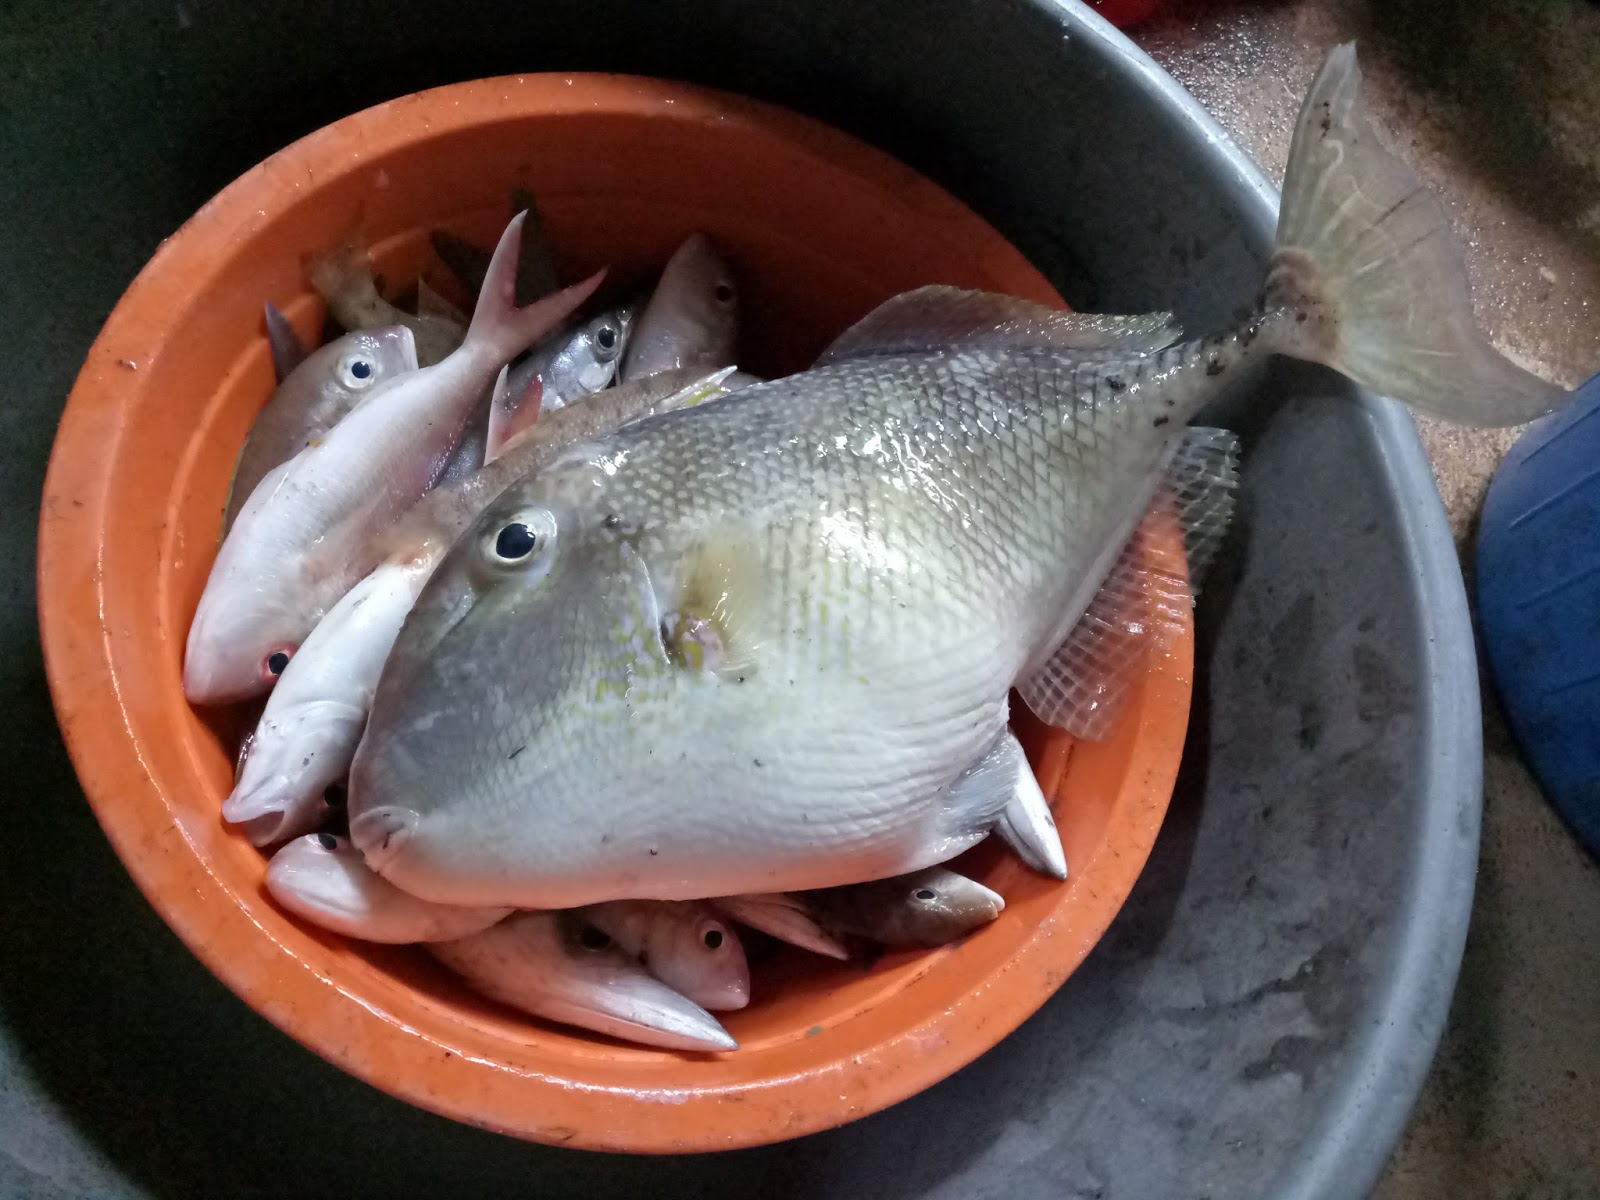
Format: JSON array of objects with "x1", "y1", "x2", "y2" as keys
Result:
[{"x1": 1016, "y1": 427, "x2": 1238, "y2": 741}]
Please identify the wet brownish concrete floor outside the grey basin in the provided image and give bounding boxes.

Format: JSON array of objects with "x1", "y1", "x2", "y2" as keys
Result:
[{"x1": 1136, "y1": 0, "x2": 1600, "y2": 1200}]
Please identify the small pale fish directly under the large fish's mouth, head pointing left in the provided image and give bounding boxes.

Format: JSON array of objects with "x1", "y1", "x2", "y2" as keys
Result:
[{"x1": 267, "y1": 834, "x2": 510, "y2": 944}]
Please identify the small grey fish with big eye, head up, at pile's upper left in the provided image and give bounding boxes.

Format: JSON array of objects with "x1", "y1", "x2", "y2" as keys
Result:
[{"x1": 222, "y1": 325, "x2": 418, "y2": 538}]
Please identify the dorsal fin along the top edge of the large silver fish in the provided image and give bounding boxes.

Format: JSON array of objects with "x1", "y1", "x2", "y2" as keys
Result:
[{"x1": 816, "y1": 285, "x2": 1182, "y2": 366}]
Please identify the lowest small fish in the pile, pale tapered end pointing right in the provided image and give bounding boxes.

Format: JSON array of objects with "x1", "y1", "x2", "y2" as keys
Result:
[{"x1": 427, "y1": 912, "x2": 739, "y2": 1051}]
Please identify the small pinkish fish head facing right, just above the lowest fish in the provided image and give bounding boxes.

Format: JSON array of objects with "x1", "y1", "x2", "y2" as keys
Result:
[{"x1": 573, "y1": 901, "x2": 750, "y2": 1013}]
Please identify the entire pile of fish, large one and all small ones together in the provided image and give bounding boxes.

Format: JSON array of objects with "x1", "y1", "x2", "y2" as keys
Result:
[{"x1": 184, "y1": 46, "x2": 1566, "y2": 1050}]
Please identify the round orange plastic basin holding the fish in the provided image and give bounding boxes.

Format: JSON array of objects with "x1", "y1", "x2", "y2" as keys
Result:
[{"x1": 38, "y1": 75, "x2": 1192, "y2": 1152}]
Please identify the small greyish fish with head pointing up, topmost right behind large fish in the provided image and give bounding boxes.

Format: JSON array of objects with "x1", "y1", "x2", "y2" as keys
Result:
[{"x1": 621, "y1": 234, "x2": 739, "y2": 382}]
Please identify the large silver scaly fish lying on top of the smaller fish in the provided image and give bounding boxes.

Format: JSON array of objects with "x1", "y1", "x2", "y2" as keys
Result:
[{"x1": 350, "y1": 46, "x2": 1566, "y2": 907}]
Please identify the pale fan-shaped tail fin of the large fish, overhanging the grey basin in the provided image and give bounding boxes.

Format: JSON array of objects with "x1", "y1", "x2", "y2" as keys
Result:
[{"x1": 1262, "y1": 43, "x2": 1568, "y2": 426}]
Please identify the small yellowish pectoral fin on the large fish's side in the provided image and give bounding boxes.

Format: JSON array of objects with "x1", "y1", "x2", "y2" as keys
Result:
[{"x1": 661, "y1": 530, "x2": 766, "y2": 682}]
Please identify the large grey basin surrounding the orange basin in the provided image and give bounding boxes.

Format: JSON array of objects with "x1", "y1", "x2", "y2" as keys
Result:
[{"x1": 0, "y1": 0, "x2": 1480, "y2": 1200}]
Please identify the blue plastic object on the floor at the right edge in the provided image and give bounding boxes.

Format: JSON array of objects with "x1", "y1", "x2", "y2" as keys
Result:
[{"x1": 1478, "y1": 376, "x2": 1600, "y2": 858}]
